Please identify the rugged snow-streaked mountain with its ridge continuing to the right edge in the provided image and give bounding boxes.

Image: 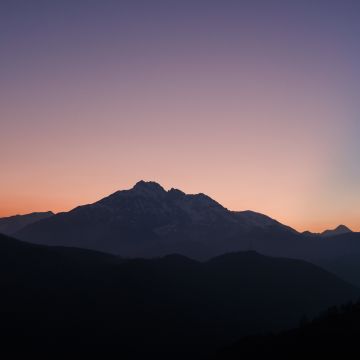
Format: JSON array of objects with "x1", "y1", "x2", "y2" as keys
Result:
[{"x1": 5, "y1": 181, "x2": 360, "y2": 284}]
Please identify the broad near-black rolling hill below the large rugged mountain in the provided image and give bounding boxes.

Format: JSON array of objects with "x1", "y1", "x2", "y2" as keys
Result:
[{"x1": 0, "y1": 236, "x2": 359, "y2": 359}]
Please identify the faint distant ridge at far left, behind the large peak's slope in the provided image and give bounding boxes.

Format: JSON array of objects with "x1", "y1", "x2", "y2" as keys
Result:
[{"x1": 0, "y1": 211, "x2": 54, "y2": 235}]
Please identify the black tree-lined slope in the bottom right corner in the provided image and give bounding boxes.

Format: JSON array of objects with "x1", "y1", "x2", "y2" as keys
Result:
[{"x1": 214, "y1": 303, "x2": 360, "y2": 360}]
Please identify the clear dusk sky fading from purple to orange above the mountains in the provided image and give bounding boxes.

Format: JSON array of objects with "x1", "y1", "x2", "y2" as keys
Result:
[{"x1": 0, "y1": 0, "x2": 360, "y2": 231}]
